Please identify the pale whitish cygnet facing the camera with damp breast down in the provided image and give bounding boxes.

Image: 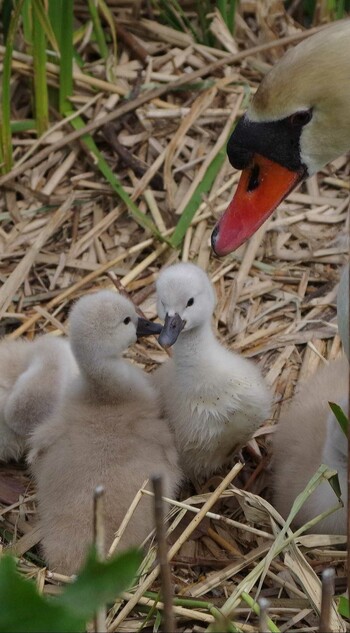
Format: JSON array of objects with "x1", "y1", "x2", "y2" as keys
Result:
[{"x1": 155, "y1": 264, "x2": 271, "y2": 479}]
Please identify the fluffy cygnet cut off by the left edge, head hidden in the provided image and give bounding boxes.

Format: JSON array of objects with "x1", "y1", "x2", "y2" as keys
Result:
[{"x1": 0, "y1": 334, "x2": 78, "y2": 461}]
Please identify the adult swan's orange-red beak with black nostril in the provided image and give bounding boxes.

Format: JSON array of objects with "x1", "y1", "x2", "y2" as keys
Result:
[{"x1": 211, "y1": 154, "x2": 304, "y2": 257}]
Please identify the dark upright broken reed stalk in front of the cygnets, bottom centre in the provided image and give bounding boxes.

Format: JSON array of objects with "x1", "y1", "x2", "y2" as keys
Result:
[{"x1": 152, "y1": 475, "x2": 176, "y2": 631}]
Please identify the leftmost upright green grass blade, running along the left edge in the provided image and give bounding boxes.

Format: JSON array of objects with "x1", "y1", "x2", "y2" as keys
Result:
[{"x1": 0, "y1": 0, "x2": 24, "y2": 173}]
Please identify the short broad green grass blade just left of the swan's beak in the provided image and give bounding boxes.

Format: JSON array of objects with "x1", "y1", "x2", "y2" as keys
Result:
[{"x1": 170, "y1": 147, "x2": 226, "y2": 248}]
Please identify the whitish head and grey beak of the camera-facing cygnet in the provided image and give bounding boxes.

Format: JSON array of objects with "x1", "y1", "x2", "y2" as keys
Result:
[{"x1": 156, "y1": 264, "x2": 215, "y2": 347}]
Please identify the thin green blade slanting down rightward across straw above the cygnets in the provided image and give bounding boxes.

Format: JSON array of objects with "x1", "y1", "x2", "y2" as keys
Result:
[{"x1": 66, "y1": 111, "x2": 162, "y2": 240}]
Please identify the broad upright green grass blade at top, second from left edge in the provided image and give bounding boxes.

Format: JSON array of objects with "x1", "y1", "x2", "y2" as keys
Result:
[{"x1": 32, "y1": 0, "x2": 49, "y2": 136}]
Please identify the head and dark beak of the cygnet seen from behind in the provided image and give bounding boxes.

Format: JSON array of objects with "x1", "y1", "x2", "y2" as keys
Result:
[{"x1": 69, "y1": 290, "x2": 161, "y2": 369}]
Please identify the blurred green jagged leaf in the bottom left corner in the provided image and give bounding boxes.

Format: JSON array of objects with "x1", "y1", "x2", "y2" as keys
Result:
[{"x1": 0, "y1": 548, "x2": 142, "y2": 633}]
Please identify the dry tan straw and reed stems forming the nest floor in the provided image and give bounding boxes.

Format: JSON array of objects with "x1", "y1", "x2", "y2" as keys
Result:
[{"x1": 0, "y1": 6, "x2": 350, "y2": 632}]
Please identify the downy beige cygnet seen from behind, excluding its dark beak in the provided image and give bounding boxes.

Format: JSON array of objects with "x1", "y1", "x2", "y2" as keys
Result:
[{"x1": 29, "y1": 291, "x2": 181, "y2": 574}]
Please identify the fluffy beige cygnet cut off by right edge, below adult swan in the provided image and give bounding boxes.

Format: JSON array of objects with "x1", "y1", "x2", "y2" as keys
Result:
[{"x1": 273, "y1": 358, "x2": 349, "y2": 534}]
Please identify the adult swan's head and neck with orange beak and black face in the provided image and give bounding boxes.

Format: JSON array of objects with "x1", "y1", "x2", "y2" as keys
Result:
[{"x1": 212, "y1": 20, "x2": 350, "y2": 256}]
